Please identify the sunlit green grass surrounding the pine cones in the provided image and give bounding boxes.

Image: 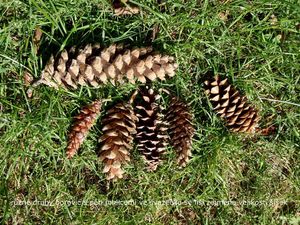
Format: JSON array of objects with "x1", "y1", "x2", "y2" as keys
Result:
[{"x1": 0, "y1": 0, "x2": 300, "y2": 224}]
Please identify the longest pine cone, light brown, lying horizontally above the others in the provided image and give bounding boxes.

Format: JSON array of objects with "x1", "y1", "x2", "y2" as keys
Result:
[{"x1": 38, "y1": 44, "x2": 178, "y2": 89}]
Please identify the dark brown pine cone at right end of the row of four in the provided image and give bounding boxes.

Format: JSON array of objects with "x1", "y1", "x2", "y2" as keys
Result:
[{"x1": 166, "y1": 97, "x2": 195, "y2": 167}]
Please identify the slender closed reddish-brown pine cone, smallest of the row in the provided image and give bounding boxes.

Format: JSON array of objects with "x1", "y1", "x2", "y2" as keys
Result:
[{"x1": 67, "y1": 100, "x2": 102, "y2": 159}]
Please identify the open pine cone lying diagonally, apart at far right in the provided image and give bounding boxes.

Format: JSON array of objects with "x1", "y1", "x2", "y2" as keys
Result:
[{"x1": 204, "y1": 76, "x2": 259, "y2": 133}]
